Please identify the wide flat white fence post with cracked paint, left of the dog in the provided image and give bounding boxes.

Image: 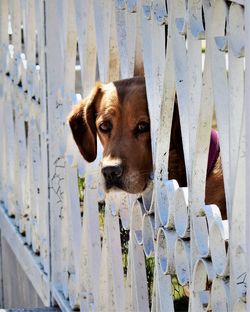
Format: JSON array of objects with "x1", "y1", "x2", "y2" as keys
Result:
[{"x1": 45, "y1": 1, "x2": 64, "y2": 296}]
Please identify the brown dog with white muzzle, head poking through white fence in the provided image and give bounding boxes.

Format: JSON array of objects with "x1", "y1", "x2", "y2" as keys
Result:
[{"x1": 68, "y1": 77, "x2": 226, "y2": 219}]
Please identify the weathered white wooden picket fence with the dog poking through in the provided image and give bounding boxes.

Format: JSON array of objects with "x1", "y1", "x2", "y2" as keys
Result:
[{"x1": 0, "y1": 0, "x2": 250, "y2": 312}]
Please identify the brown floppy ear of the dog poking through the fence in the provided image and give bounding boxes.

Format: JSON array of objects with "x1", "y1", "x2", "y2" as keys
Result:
[{"x1": 68, "y1": 83, "x2": 101, "y2": 162}]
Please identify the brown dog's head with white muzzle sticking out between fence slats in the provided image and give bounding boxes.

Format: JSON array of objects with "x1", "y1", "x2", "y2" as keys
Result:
[{"x1": 69, "y1": 77, "x2": 152, "y2": 193}]
